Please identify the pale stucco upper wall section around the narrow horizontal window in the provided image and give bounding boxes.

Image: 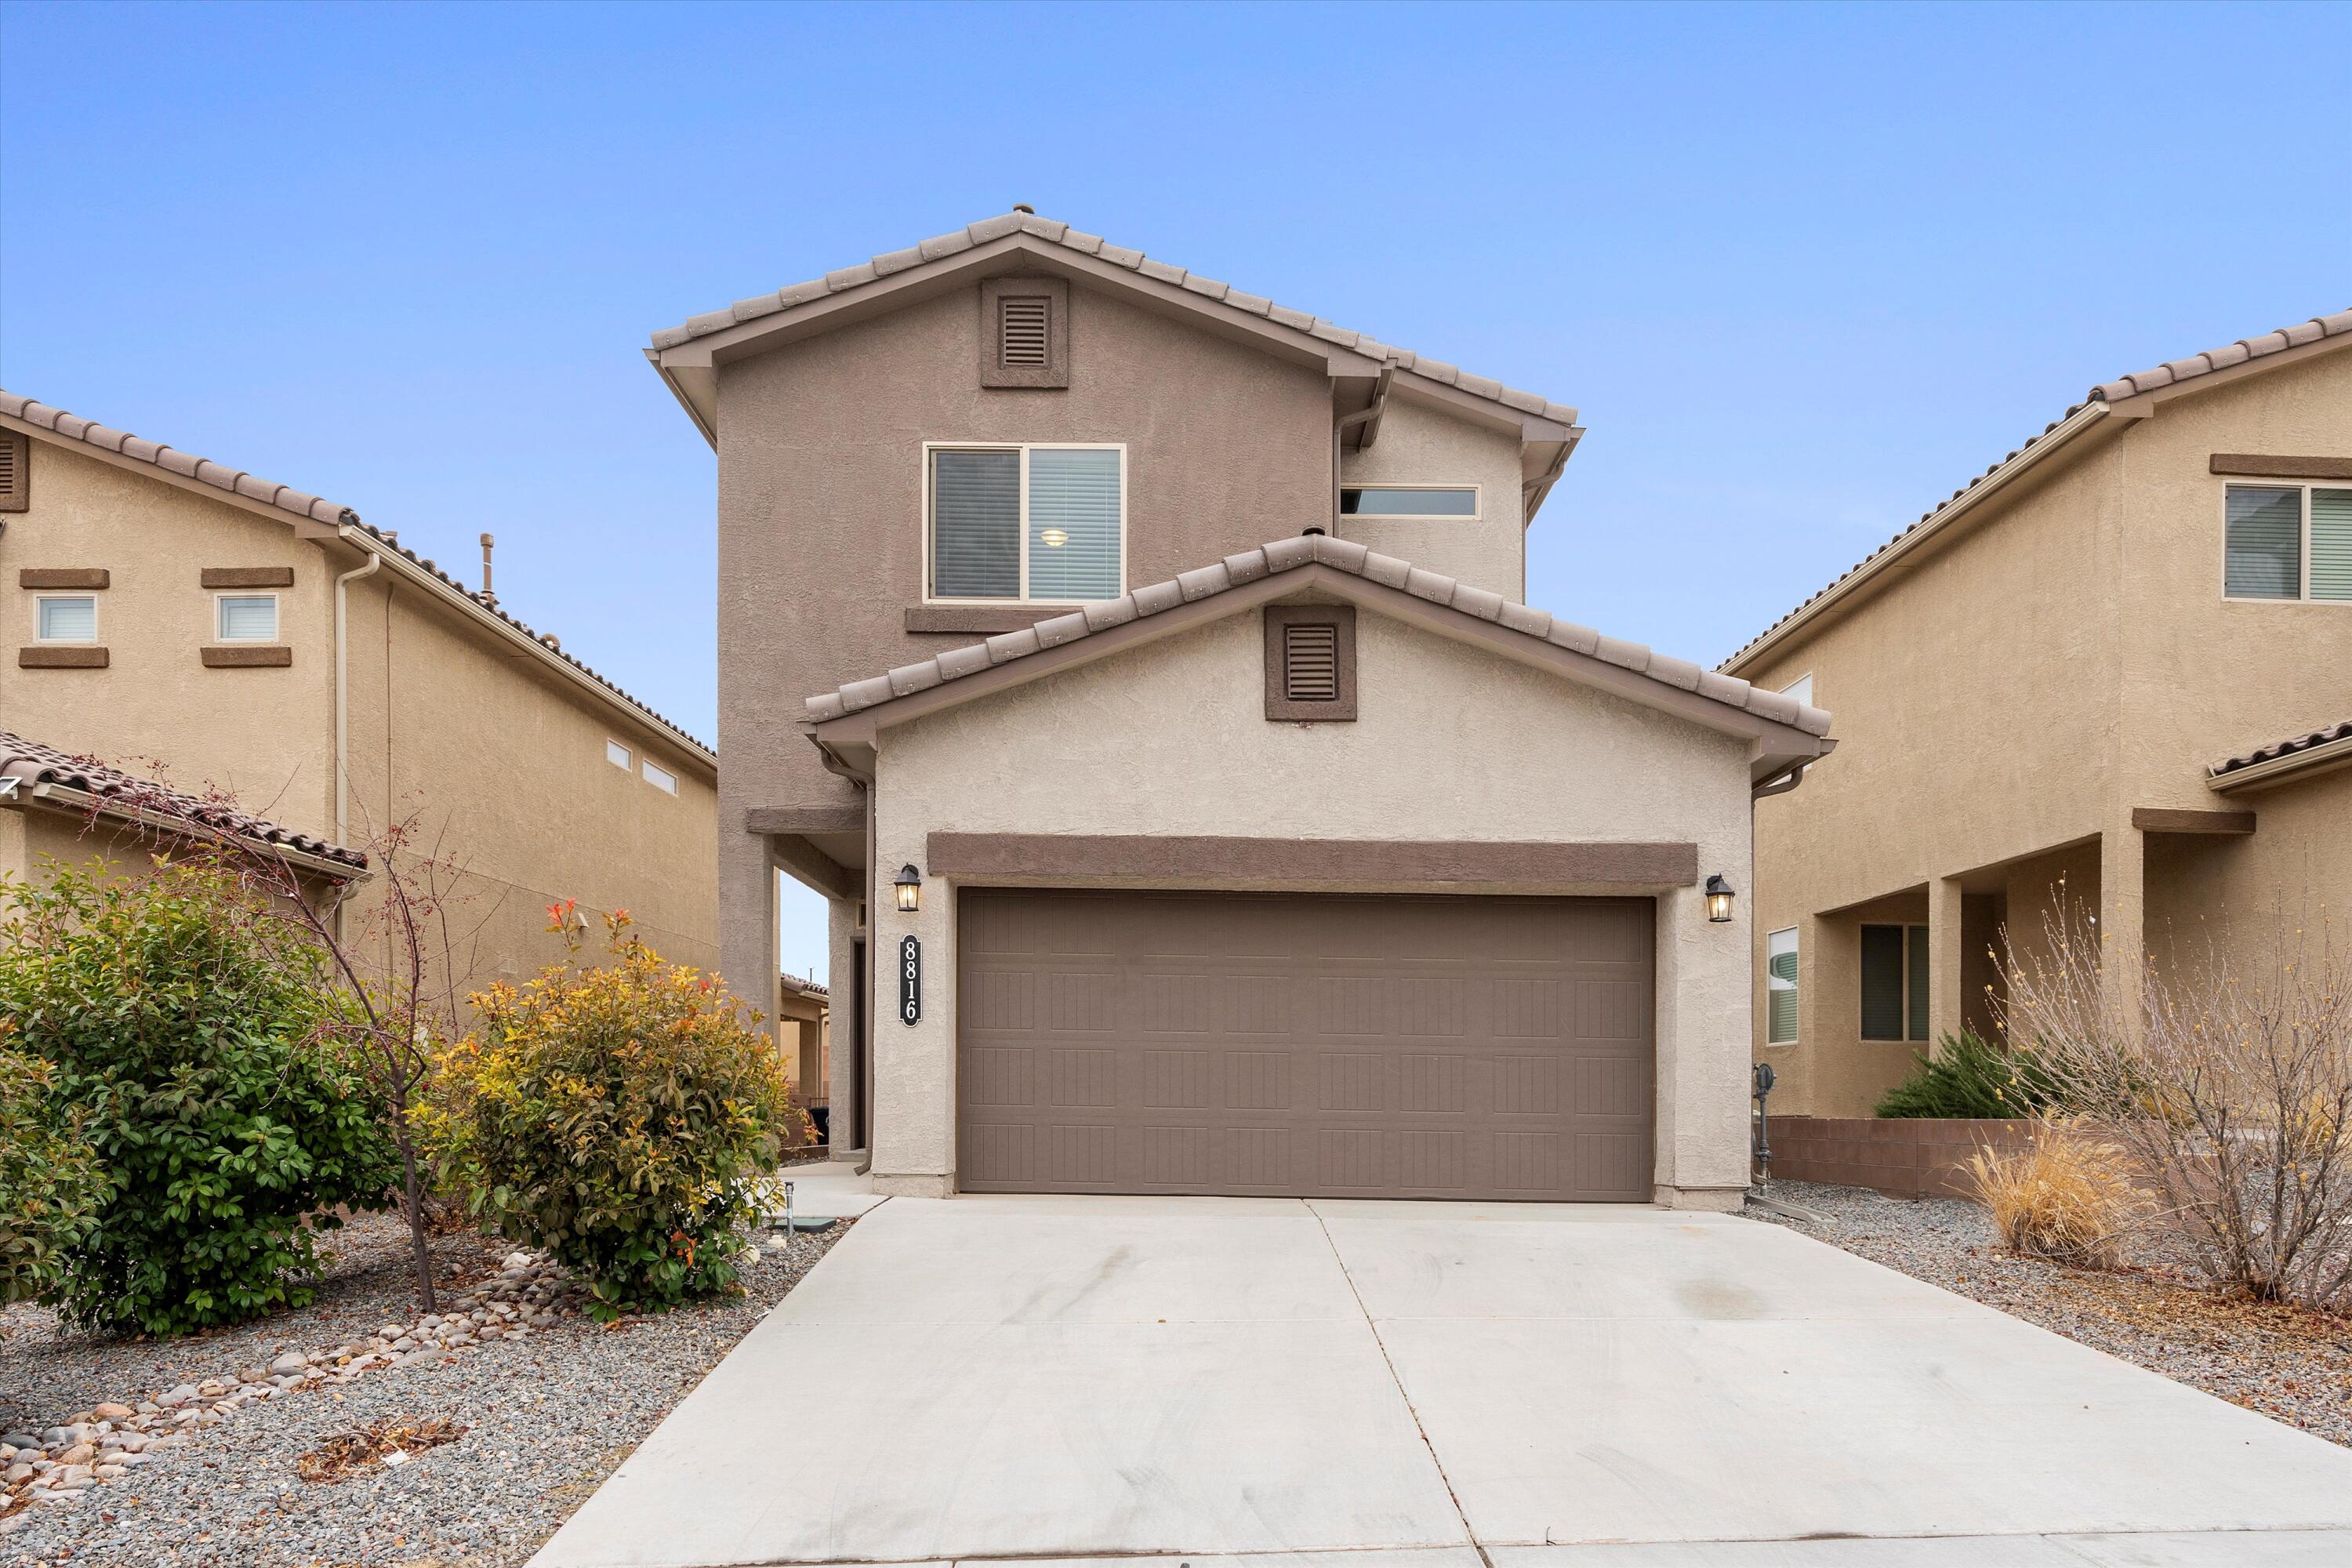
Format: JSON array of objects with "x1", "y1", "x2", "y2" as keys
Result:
[{"x1": 1338, "y1": 395, "x2": 1526, "y2": 604}]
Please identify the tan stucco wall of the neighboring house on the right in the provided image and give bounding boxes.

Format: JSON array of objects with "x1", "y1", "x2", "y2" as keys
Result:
[{"x1": 1731, "y1": 350, "x2": 2352, "y2": 1114}]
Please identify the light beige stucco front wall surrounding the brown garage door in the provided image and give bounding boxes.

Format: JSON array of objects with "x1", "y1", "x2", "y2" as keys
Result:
[{"x1": 873, "y1": 612, "x2": 1748, "y2": 1189}]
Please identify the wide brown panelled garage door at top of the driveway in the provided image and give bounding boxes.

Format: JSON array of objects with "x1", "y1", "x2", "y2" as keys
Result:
[{"x1": 957, "y1": 888, "x2": 1653, "y2": 1201}]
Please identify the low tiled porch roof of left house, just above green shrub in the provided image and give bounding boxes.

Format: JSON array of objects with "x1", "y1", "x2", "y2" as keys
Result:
[{"x1": 0, "y1": 729, "x2": 367, "y2": 909}]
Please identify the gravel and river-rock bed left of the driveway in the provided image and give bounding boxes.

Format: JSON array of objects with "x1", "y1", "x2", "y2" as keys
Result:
[{"x1": 0, "y1": 1215, "x2": 847, "y2": 1568}]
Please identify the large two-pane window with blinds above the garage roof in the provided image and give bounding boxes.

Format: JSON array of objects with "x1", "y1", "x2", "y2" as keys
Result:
[{"x1": 922, "y1": 442, "x2": 1127, "y2": 604}]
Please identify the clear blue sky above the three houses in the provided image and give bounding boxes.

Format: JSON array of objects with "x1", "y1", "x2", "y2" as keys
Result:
[{"x1": 0, "y1": 2, "x2": 2352, "y2": 968}]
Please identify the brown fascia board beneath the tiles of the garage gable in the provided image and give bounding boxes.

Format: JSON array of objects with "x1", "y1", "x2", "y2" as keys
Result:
[{"x1": 802, "y1": 562, "x2": 1830, "y2": 771}]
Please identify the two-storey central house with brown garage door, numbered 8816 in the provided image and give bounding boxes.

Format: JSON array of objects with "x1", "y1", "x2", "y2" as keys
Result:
[{"x1": 649, "y1": 209, "x2": 1830, "y2": 1206}]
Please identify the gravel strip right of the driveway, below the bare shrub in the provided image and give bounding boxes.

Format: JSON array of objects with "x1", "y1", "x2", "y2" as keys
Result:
[{"x1": 1748, "y1": 1180, "x2": 2352, "y2": 1448}]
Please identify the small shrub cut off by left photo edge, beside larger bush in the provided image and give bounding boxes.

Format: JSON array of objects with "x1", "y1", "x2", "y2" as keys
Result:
[{"x1": 0, "y1": 1048, "x2": 106, "y2": 1307}]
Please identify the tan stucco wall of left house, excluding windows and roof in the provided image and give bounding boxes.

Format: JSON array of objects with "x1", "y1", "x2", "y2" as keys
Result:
[{"x1": 0, "y1": 440, "x2": 715, "y2": 1011}]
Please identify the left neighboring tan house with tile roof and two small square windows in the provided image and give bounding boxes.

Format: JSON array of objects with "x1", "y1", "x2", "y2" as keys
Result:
[{"x1": 0, "y1": 393, "x2": 720, "y2": 1001}]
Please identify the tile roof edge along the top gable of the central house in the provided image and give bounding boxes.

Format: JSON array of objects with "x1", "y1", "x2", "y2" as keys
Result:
[{"x1": 654, "y1": 212, "x2": 1576, "y2": 426}]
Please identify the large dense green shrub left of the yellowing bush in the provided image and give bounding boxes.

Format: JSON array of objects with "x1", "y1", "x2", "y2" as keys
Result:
[{"x1": 0, "y1": 860, "x2": 395, "y2": 1333}]
